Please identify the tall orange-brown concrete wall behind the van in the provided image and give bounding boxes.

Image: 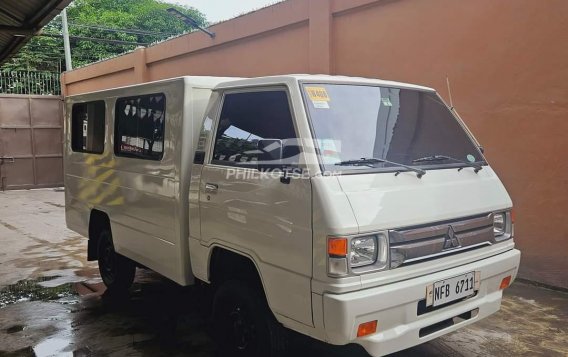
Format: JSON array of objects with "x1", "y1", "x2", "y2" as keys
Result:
[{"x1": 62, "y1": 0, "x2": 568, "y2": 287}]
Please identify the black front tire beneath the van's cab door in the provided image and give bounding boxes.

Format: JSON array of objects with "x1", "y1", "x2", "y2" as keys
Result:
[{"x1": 211, "y1": 280, "x2": 288, "y2": 357}]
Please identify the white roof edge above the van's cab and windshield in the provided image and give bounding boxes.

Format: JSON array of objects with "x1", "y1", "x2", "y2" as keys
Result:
[{"x1": 215, "y1": 74, "x2": 435, "y2": 92}]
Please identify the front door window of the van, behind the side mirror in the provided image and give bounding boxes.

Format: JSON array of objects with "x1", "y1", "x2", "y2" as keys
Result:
[{"x1": 212, "y1": 90, "x2": 300, "y2": 168}]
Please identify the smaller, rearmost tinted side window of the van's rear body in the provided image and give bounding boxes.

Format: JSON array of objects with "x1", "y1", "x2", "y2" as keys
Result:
[{"x1": 71, "y1": 100, "x2": 105, "y2": 154}]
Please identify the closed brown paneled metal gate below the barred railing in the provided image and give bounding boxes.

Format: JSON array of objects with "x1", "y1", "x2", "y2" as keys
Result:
[{"x1": 0, "y1": 95, "x2": 63, "y2": 190}]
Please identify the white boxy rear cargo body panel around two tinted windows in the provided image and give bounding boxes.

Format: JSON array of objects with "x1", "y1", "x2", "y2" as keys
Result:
[{"x1": 64, "y1": 77, "x2": 237, "y2": 285}]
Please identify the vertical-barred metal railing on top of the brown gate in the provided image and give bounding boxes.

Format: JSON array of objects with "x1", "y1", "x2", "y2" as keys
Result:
[{"x1": 0, "y1": 71, "x2": 61, "y2": 95}]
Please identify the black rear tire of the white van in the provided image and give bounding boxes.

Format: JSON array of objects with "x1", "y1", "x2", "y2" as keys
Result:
[{"x1": 98, "y1": 230, "x2": 136, "y2": 293}]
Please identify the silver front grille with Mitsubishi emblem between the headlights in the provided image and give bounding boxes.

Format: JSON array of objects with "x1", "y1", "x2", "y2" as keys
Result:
[{"x1": 389, "y1": 213, "x2": 495, "y2": 268}]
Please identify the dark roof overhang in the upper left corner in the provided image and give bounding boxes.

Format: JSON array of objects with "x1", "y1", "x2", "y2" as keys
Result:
[{"x1": 0, "y1": 0, "x2": 72, "y2": 65}]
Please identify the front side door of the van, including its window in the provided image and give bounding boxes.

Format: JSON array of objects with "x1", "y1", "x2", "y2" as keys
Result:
[{"x1": 199, "y1": 87, "x2": 313, "y2": 326}]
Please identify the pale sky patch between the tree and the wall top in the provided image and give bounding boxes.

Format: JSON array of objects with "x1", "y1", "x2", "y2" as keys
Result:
[{"x1": 173, "y1": 0, "x2": 278, "y2": 23}]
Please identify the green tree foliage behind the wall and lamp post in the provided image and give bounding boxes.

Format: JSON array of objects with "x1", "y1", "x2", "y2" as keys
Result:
[{"x1": 2, "y1": 0, "x2": 207, "y2": 71}]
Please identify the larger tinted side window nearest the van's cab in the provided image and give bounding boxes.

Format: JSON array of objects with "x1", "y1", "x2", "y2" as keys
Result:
[{"x1": 114, "y1": 94, "x2": 166, "y2": 160}]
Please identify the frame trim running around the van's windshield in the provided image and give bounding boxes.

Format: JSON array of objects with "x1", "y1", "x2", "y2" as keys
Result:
[{"x1": 298, "y1": 80, "x2": 489, "y2": 176}]
